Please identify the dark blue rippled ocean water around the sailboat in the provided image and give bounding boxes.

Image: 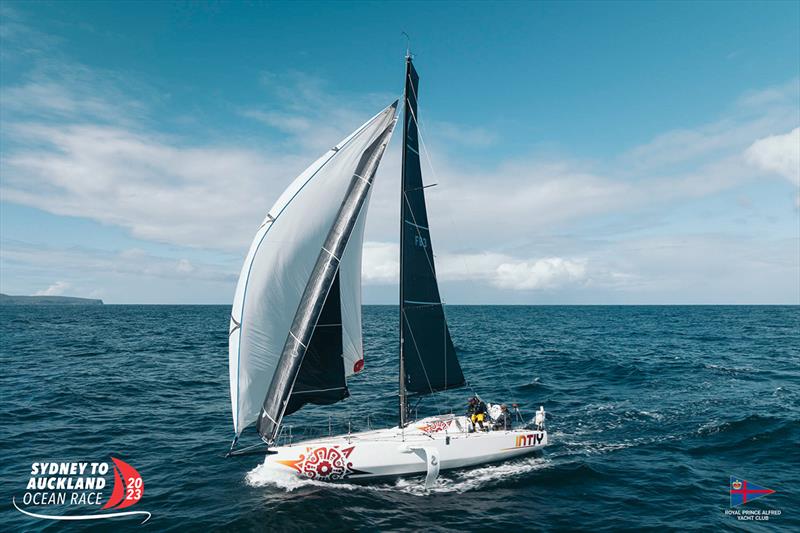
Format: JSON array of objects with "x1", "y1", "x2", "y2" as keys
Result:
[{"x1": 0, "y1": 305, "x2": 800, "y2": 531}]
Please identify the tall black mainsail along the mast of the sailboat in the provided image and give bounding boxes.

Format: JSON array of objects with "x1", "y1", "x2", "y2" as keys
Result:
[{"x1": 400, "y1": 55, "x2": 465, "y2": 427}]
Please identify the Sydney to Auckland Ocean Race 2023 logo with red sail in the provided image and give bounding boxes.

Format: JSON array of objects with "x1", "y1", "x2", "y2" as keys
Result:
[{"x1": 12, "y1": 457, "x2": 151, "y2": 524}]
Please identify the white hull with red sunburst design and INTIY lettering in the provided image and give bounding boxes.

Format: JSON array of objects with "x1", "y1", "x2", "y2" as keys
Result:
[{"x1": 264, "y1": 415, "x2": 547, "y2": 485}]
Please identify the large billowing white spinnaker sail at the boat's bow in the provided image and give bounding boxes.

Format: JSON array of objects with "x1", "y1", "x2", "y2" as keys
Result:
[{"x1": 228, "y1": 106, "x2": 394, "y2": 435}]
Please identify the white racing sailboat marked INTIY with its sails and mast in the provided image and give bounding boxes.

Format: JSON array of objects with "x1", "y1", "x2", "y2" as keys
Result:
[{"x1": 229, "y1": 53, "x2": 548, "y2": 487}]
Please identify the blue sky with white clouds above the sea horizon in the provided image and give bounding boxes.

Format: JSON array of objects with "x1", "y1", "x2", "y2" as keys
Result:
[{"x1": 0, "y1": 2, "x2": 800, "y2": 304}]
